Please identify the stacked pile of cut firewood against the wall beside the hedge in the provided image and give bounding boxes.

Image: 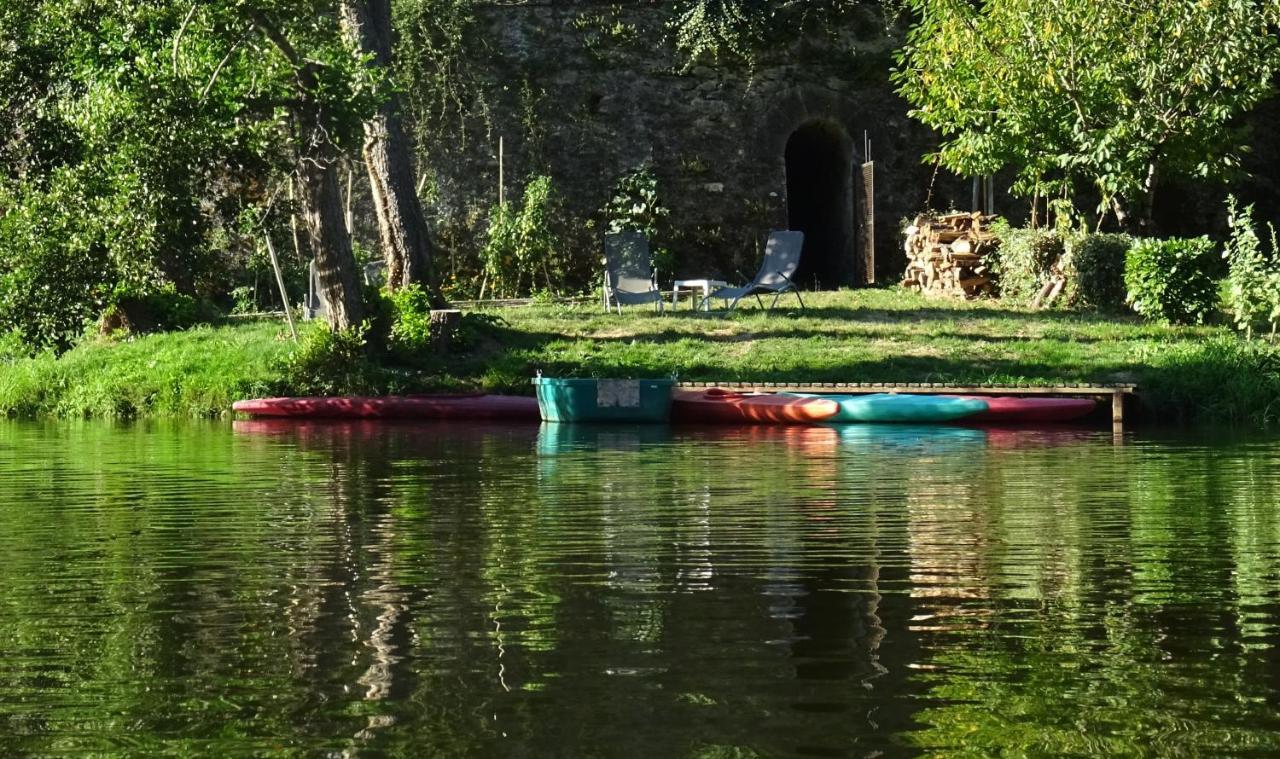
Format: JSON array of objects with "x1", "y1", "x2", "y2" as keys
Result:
[{"x1": 902, "y1": 214, "x2": 1000, "y2": 298}]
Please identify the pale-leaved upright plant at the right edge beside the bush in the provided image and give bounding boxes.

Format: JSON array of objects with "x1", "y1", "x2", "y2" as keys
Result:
[{"x1": 1222, "y1": 196, "x2": 1280, "y2": 337}]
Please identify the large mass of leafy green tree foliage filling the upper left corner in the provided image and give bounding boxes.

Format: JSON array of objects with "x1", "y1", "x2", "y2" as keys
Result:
[{"x1": 0, "y1": 0, "x2": 385, "y2": 348}]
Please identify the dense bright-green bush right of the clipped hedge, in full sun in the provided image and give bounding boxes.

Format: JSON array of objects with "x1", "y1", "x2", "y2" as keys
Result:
[{"x1": 1124, "y1": 237, "x2": 1219, "y2": 324}]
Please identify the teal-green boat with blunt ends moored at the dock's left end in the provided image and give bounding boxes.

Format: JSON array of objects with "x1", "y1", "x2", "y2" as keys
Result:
[{"x1": 534, "y1": 376, "x2": 676, "y2": 424}]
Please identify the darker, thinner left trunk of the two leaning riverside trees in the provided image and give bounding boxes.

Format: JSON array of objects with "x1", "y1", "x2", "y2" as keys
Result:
[{"x1": 298, "y1": 157, "x2": 364, "y2": 330}]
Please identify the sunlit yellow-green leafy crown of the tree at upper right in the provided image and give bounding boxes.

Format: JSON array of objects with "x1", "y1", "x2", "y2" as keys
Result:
[{"x1": 895, "y1": 0, "x2": 1280, "y2": 223}]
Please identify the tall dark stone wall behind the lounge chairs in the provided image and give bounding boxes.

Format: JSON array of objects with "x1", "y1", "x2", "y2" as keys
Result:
[{"x1": 414, "y1": 5, "x2": 969, "y2": 287}]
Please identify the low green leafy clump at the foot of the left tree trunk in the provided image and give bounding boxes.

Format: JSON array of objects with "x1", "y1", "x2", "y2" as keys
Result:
[{"x1": 279, "y1": 323, "x2": 384, "y2": 395}]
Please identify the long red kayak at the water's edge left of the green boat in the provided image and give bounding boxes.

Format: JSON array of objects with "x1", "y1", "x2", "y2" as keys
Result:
[{"x1": 232, "y1": 394, "x2": 540, "y2": 421}]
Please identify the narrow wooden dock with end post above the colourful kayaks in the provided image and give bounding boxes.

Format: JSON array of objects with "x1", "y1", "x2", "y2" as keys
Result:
[{"x1": 676, "y1": 383, "x2": 1138, "y2": 425}]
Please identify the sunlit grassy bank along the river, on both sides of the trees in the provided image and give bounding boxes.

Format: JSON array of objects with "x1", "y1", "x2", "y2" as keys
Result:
[{"x1": 0, "y1": 289, "x2": 1280, "y2": 424}]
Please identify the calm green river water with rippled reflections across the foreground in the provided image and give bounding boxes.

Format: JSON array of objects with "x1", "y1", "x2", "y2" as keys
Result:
[{"x1": 0, "y1": 422, "x2": 1280, "y2": 756}]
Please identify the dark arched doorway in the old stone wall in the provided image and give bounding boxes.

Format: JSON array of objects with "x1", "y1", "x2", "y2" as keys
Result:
[{"x1": 786, "y1": 120, "x2": 856, "y2": 289}]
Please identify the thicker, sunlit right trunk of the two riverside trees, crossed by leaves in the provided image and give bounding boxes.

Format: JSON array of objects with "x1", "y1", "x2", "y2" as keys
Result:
[{"x1": 342, "y1": 0, "x2": 436, "y2": 300}]
